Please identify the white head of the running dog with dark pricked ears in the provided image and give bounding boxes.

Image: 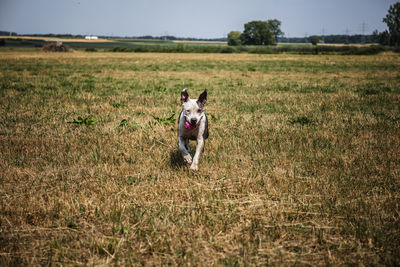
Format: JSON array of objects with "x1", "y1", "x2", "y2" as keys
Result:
[{"x1": 181, "y1": 88, "x2": 207, "y2": 128}]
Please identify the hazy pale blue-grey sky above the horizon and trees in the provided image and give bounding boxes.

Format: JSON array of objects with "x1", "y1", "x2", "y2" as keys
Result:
[{"x1": 0, "y1": 0, "x2": 398, "y2": 38}]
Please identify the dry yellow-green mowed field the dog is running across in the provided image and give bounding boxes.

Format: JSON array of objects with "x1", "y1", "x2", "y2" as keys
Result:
[{"x1": 0, "y1": 51, "x2": 400, "y2": 266}]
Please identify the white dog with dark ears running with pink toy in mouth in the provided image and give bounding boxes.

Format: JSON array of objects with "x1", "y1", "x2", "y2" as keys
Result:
[{"x1": 178, "y1": 88, "x2": 209, "y2": 171}]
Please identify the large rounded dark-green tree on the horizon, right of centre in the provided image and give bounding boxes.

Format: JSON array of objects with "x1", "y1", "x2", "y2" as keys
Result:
[{"x1": 241, "y1": 20, "x2": 275, "y2": 45}]
